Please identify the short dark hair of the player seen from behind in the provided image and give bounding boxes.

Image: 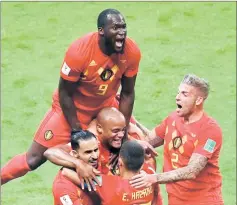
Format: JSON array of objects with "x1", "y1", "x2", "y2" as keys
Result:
[{"x1": 119, "y1": 140, "x2": 145, "y2": 172}]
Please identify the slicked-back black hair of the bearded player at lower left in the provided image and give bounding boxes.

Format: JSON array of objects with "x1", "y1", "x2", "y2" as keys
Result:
[{"x1": 71, "y1": 130, "x2": 97, "y2": 150}]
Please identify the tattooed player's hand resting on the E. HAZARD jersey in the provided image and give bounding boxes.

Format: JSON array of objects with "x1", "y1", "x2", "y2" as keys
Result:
[{"x1": 129, "y1": 170, "x2": 156, "y2": 188}]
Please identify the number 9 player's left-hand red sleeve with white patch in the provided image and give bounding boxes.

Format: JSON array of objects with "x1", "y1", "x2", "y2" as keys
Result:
[{"x1": 60, "y1": 38, "x2": 86, "y2": 82}]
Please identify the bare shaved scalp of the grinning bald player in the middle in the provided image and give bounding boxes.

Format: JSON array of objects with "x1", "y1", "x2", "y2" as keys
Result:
[{"x1": 96, "y1": 107, "x2": 125, "y2": 126}]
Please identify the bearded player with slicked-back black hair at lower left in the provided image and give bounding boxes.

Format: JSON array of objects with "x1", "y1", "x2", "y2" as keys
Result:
[{"x1": 53, "y1": 131, "x2": 100, "y2": 205}]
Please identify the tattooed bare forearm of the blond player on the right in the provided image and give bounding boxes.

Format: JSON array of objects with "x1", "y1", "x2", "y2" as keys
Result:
[{"x1": 157, "y1": 153, "x2": 208, "y2": 184}]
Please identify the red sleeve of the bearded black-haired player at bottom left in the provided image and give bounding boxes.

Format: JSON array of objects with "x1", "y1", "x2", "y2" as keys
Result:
[{"x1": 53, "y1": 179, "x2": 81, "y2": 205}]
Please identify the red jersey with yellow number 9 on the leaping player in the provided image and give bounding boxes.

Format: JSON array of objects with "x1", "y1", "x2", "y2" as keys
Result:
[{"x1": 54, "y1": 32, "x2": 141, "y2": 125}]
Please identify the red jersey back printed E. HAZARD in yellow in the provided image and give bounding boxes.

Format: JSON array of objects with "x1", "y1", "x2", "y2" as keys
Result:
[{"x1": 96, "y1": 164, "x2": 155, "y2": 205}]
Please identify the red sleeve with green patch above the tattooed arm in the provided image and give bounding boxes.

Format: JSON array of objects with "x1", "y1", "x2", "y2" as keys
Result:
[{"x1": 194, "y1": 125, "x2": 222, "y2": 159}]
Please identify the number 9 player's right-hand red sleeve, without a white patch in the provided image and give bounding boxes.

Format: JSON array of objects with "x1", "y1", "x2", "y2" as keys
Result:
[{"x1": 124, "y1": 38, "x2": 141, "y2": 77}]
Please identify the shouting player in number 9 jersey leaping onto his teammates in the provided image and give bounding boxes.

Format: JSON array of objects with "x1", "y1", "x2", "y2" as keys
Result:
[{"x1": 1, "y1": 9, "x2": 141, "y2": 184}]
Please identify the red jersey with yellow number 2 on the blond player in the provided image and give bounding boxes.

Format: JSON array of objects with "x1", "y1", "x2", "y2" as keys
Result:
[{"x1": 155, "y1": 112, "x2": 223, "y2": 205}]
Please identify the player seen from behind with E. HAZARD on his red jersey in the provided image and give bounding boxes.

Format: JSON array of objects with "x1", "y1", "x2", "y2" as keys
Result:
[{"x1": 54, "y1": 140, "x2": 157, "y2": 205}]
